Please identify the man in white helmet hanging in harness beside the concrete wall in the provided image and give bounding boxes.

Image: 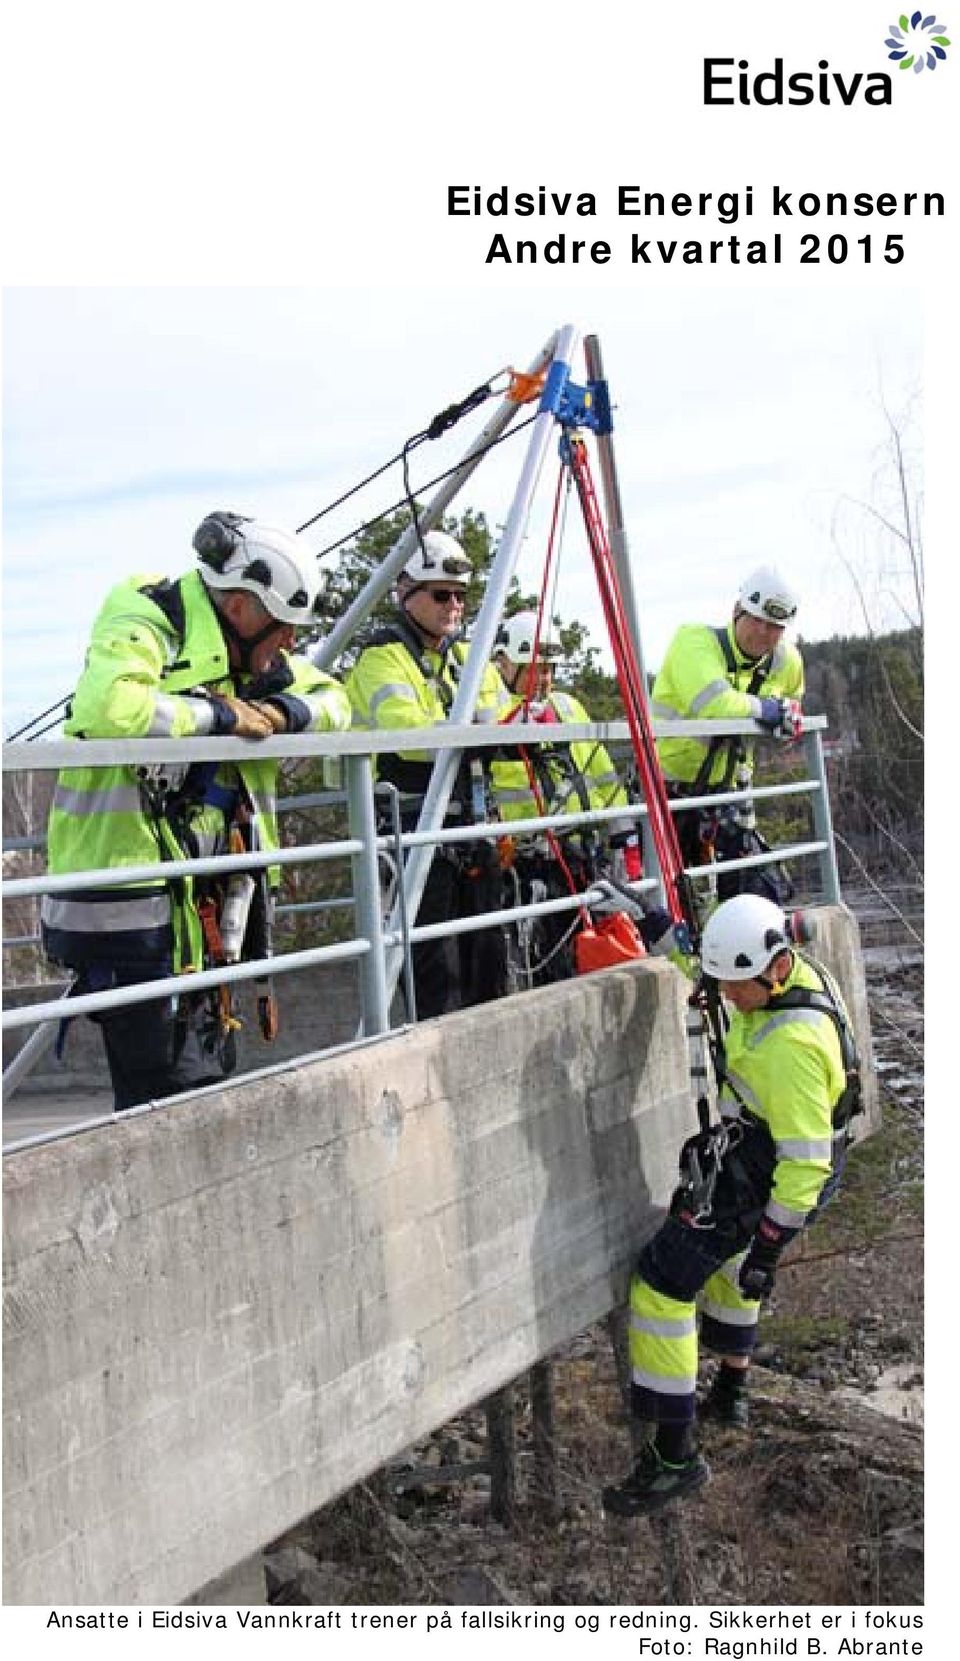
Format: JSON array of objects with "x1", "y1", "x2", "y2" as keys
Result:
[{"x1": 603, "y1": 894, "x2": 855, "y2": 1516}]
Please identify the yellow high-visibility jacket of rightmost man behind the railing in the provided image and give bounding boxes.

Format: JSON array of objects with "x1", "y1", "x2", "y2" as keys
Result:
[{"x1": 651, "y1": 623, "x2": 804, "y2": 786}]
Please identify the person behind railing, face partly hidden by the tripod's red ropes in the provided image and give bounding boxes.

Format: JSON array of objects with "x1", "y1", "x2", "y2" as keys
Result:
[{"x1": 490, "y1": 611, "x2": 641, "y2": 983}]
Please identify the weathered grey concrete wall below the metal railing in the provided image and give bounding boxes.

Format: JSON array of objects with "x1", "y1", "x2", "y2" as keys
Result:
[{"x1": 3, "y1": 912, "x2": 865, "y2": 1605}]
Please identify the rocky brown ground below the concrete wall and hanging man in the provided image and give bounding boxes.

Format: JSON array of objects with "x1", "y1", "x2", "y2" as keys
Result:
[{"x1": 267, "y1": 950, "x2": 923, "y2": 1606}]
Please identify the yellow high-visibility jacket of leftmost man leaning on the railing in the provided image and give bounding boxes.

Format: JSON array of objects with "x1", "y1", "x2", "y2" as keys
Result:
[{"x1": 42, "y1": 571, "x2": 350, "y2": 970}]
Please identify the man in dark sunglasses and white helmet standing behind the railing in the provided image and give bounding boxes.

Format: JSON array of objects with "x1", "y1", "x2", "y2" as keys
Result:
[{"x1": 345, "y1": 530, "x2": 507, "y2": 1017}]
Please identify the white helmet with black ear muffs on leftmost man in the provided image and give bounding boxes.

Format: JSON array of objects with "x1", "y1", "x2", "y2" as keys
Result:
[{"x1": 193, "y1": 513, "x2": 327, "y2": 628}]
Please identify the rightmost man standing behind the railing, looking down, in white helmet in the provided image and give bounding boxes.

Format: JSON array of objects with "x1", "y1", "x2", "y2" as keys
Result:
[{"x1": 651, "y1": 566, "x2": 804, "y2": 904}]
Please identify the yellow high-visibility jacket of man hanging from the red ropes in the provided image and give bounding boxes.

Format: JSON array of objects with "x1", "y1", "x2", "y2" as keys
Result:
[{"x1": 721, "y1": 952, "x2": 845, "y2": 1229}]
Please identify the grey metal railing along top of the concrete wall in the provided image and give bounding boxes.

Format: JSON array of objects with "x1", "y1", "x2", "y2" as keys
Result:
[{"x1": 2, "y1": 716, "x2": 840, "y2": 1088}]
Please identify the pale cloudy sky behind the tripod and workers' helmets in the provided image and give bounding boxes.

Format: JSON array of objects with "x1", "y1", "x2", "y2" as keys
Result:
[{"x1": 3, "y1": 287, "x2": 922, "y2": 733}]
